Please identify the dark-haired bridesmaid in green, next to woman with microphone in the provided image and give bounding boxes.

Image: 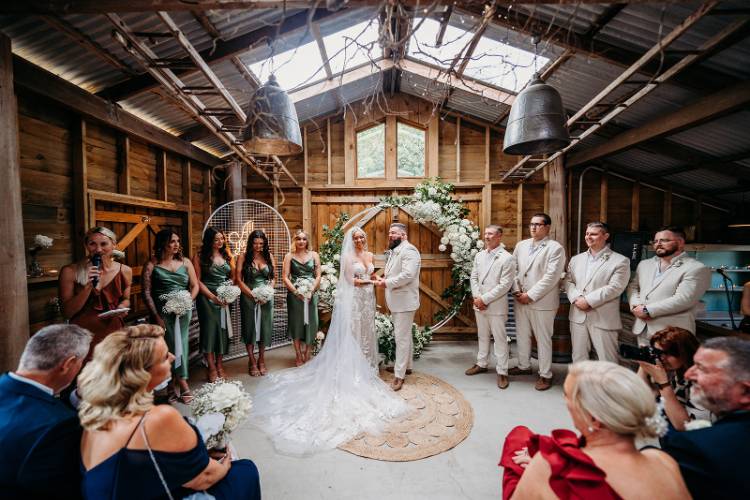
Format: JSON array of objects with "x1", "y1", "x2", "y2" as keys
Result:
[{"x1": 141, "y1": 229, "x2": 200, "y2": 404}]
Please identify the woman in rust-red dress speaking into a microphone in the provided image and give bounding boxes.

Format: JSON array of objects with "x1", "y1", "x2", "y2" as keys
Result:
[{"x1": 59, "y1": 227, "x2": 133, "y2": 360}]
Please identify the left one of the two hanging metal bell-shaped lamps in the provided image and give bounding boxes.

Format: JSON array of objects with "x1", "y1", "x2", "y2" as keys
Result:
[{"x1": 242, "y1": 75, "x2": 302, "y2": 156}]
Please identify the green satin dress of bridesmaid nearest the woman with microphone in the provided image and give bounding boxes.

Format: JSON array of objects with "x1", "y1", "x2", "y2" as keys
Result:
[{"x1": 151, "y1": 264, "x2": 193, "y2": 379}]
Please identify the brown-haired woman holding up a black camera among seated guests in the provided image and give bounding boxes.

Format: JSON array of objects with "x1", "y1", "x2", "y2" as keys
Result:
[{"x1": 638, "y1": 326, "x2": 711, "y2": 431}]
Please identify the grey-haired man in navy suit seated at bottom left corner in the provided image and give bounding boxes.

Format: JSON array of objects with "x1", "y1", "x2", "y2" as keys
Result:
[{"x1": 0, "y1": 325, "x2": 91, "y2": 500}]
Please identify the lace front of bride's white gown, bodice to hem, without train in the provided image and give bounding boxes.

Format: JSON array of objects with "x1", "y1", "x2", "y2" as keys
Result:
[{"x1": 352, "y1": 262, "x2": 380, "y2": 373}]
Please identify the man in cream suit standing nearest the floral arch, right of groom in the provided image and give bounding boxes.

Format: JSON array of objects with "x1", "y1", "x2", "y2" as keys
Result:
[{"x1": 466, "y1": 225, "x2": 516, "y2": 389}]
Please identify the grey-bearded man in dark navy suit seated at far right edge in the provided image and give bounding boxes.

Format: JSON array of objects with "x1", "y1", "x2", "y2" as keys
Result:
[{"x1": 662, "y1": 337, "x2": 750, "y2": 499}]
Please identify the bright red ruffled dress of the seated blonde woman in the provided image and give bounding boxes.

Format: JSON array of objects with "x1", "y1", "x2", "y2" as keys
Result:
[{"x1": 498, "y1": 426, "x2": 621, "y2": 500}]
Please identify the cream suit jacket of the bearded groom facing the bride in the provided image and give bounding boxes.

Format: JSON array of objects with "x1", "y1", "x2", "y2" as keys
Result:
[{"x1": 385, "y1": 241, "x2": 422, "y2": 312}]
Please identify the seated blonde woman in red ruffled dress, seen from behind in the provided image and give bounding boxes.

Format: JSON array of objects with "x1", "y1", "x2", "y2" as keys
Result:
[{"x1": 500, "y1": 361, "x2": 689, "y2": 500}]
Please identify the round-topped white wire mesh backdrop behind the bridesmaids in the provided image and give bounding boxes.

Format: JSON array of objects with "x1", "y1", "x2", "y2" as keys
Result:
[{"x1": 203, "y1": 200, "x2": 292, "y2": 359}]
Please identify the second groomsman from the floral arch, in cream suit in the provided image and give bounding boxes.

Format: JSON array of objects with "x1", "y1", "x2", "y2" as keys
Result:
[{"x1": 508, "y1": 213, "x2": 565, "y2": 391}]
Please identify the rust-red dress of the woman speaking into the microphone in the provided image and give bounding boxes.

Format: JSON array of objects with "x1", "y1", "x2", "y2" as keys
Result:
[{"x1": 70, "y1": 264, "x2": 128, "y2": 361}]
